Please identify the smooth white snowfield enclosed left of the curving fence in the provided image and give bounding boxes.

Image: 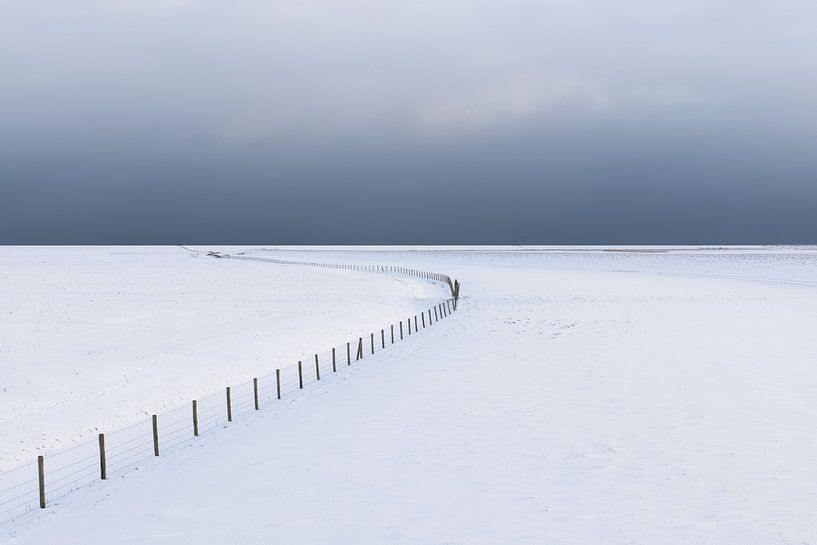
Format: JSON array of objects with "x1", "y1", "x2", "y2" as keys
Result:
[{"x1": 0, "y1": 247, "x2": 445, "y2": 464}]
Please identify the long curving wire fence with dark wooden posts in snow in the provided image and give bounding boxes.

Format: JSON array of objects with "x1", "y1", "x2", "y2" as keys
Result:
[{"x1": 0, "y1": 255, "x2": 459, "y2": 524}]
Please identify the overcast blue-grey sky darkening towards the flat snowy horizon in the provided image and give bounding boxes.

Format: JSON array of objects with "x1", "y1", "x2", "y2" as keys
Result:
[{"x1": 0, "y1": 0, "x2": 817, "y2": 244}]
